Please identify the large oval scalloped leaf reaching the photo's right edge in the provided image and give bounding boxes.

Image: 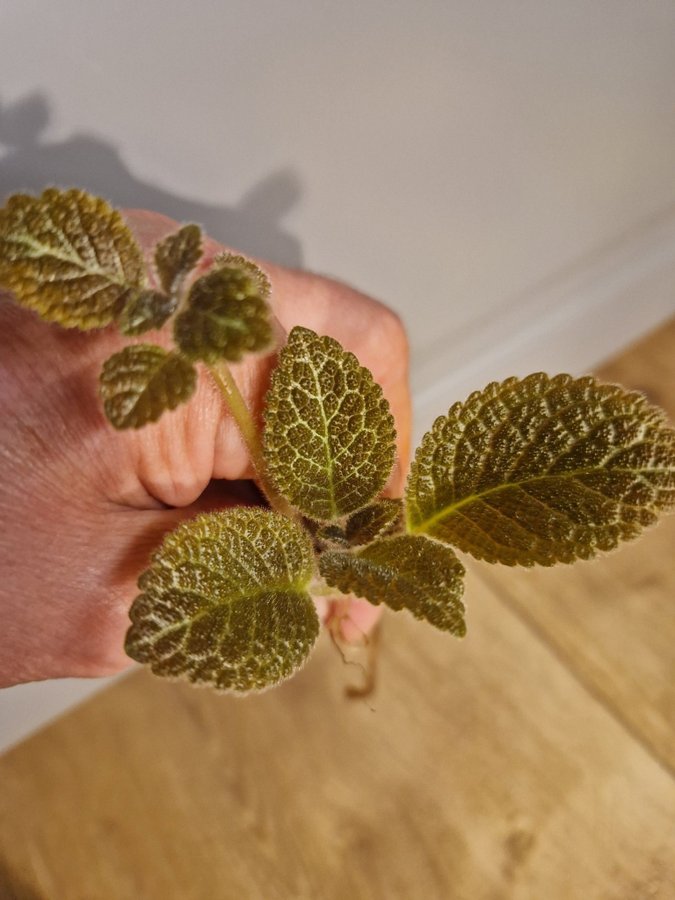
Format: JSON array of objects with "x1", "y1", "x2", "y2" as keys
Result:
[{"x1": 406, "y1": 373, "x2": 675, "y2": 566}]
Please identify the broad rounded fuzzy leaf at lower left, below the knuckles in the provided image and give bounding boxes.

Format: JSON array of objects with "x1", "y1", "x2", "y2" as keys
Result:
[{"x1": 126, "y1": 509, "x2": 319, "y2": 691}]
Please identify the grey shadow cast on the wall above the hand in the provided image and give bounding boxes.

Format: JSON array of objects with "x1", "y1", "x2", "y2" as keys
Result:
[{"x1": 0, "y1": 93, "x2": 302, "y2": 267}]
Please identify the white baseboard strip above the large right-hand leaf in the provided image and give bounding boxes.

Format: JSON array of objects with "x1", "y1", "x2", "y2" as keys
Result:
[{"x1": 413, "y1": 207, "x2": 675, "y2": 437}]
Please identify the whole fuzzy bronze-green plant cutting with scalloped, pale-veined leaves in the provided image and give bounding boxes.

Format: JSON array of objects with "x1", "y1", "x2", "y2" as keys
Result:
[{"x1": 0, "y1": 188, "x2": 675, "y2": 692}]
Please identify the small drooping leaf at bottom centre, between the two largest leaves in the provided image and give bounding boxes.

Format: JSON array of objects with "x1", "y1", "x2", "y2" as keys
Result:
[{"x1": 319, "y1": 534, "x2": 466, "y2": 637}]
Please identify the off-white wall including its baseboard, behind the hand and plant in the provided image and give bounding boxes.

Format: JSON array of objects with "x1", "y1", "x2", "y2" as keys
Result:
[{"x1": 0, "y1": 0, "x2": 675, "y2": 741}]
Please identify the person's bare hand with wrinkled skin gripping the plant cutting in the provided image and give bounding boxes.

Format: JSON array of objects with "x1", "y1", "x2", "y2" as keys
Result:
[{"x1": 0, "y1": 210, "x2": 410, "y2": 686}]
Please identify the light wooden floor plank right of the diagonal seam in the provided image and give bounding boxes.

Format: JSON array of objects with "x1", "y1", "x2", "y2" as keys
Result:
[{"x1": 477, "y1": 319, "x2": 675, "y2": 772}]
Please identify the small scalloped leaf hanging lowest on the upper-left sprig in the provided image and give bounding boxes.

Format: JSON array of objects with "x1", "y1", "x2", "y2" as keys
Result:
[{"x1": 101, "y1": 344, "x2": 197, "y2": 429}]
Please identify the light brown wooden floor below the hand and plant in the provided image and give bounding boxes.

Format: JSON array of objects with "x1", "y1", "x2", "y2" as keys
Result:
[{"x1": 0, "y1": 321, "x2": 675, "y2": 900}]
